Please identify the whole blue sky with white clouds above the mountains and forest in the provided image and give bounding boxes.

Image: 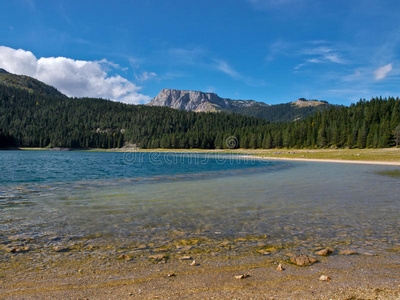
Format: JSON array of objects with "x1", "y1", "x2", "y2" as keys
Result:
[{"x1": 0, "y1": 0, "x2": 400, "y2": 105}]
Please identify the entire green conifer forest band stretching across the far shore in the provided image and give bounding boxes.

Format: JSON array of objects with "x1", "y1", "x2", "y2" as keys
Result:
[{"x1": 0, "y1": 85, "x2": 400, "y2": 149}]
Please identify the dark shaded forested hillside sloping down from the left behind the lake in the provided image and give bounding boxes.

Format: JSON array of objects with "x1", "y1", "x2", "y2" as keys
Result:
[{"x1": 0, "y1": 85, "x2": 267, "y2": 148}]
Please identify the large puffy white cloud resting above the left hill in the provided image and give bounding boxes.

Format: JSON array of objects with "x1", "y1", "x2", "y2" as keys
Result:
[{"x1": 0, "y1": 46, "x2": 150, "y2": 104}]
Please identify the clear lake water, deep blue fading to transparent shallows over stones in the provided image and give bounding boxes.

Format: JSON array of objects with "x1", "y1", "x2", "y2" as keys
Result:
[{"x1": 0, "y1": 151, "x2": 400, "y2": 250}]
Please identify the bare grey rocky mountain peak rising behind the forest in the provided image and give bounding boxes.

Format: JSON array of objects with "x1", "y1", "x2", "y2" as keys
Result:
[{"x1": 147, "y1": 89, "x2": 268, "y2": 112}]
